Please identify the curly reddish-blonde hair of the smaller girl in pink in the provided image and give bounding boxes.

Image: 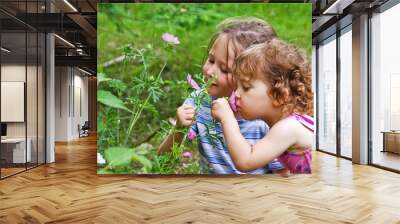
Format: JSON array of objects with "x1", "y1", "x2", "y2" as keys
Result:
[{"x1": 233, "y1": 39, "x2": 313, "y2": 116}]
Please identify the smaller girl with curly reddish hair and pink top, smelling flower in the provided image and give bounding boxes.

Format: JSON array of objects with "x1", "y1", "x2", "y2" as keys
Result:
[{"x1": 212, "y1": 39, "x2": 314, "y2": 174}]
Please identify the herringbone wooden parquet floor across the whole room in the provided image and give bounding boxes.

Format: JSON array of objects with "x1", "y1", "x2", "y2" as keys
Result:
[{"x1": 0, "y1": 137, "x2": 400, "y2": 224}]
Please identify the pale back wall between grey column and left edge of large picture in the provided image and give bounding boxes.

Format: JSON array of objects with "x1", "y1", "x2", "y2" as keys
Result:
[{"x1": 55, "y1": 67, "x2": 88, "y2": 141}]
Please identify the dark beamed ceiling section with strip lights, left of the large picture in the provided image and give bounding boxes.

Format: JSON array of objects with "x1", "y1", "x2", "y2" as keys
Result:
[{"x1": 0, "y1": 0, "x2": 99, "y2": 74}]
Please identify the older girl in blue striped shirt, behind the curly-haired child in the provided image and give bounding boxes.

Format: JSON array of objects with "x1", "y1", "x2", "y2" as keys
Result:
[{"x1": 158, "y1": 17, "x2": 283, "y2": 174}]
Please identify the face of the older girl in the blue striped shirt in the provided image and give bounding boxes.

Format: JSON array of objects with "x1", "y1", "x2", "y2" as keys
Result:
[{"x1": 203, "y1": 34, "x2": 235, "y2": 97}]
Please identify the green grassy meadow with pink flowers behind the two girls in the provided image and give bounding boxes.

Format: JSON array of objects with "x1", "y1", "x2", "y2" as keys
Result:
[{"x1": 97, "y1": 3, "x2": 312, "y2": 174}]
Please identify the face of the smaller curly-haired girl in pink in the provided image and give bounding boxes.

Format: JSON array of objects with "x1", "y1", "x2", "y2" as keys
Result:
[{"x1": 235, "y1": 79, "x2": 280, "y2": 123}]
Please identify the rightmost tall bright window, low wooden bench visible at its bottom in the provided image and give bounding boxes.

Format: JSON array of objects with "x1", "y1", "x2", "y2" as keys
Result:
[{"x1": 370, "y1": 1, "x2": 400, "y2": 170}]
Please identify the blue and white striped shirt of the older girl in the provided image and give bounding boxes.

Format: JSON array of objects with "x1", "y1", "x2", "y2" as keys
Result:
[{"x1": 184, "y1": 92, "x2": 283, "y2": 174}]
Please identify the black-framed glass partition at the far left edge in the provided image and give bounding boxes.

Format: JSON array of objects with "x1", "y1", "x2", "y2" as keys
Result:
[{"x1": 0, "y1": 1, "x2": 46, "y2": 179}]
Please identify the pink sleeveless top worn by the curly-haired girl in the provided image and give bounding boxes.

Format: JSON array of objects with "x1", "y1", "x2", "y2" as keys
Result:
[{"x1": 278, "y1": 114, "x2": 314, "y2": 173}]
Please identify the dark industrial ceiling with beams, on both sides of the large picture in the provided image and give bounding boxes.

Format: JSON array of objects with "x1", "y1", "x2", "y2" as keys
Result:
[{"x1": 0, "y1": 0, "x2": 387, "y2": 72}]
